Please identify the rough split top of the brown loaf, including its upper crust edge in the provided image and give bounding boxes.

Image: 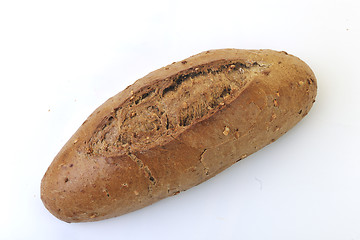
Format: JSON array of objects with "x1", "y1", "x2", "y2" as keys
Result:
[{"x1": 74, "y1": 49, "x2": 312, "y2": 157}]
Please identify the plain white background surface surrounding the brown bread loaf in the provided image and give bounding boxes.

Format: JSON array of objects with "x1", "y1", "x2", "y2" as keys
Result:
[{"x1": 0, "y1": 0, "x2": 360, "y2": 240}]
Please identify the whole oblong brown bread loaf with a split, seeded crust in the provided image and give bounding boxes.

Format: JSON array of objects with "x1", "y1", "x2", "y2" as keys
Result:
[{"x1": 41, "y1": 49, "x2": 317, "y2": 222}]
